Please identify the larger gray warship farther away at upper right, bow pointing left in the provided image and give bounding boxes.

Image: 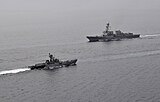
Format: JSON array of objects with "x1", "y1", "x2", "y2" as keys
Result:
[{"x1": 87, "y1": 23, "x2": 140, "y2": 42}]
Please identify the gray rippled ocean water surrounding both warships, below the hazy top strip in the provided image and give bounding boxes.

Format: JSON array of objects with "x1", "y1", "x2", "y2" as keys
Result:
[{"x1": 0, "y1": 11, "x2": 160, "y2": 102}]
